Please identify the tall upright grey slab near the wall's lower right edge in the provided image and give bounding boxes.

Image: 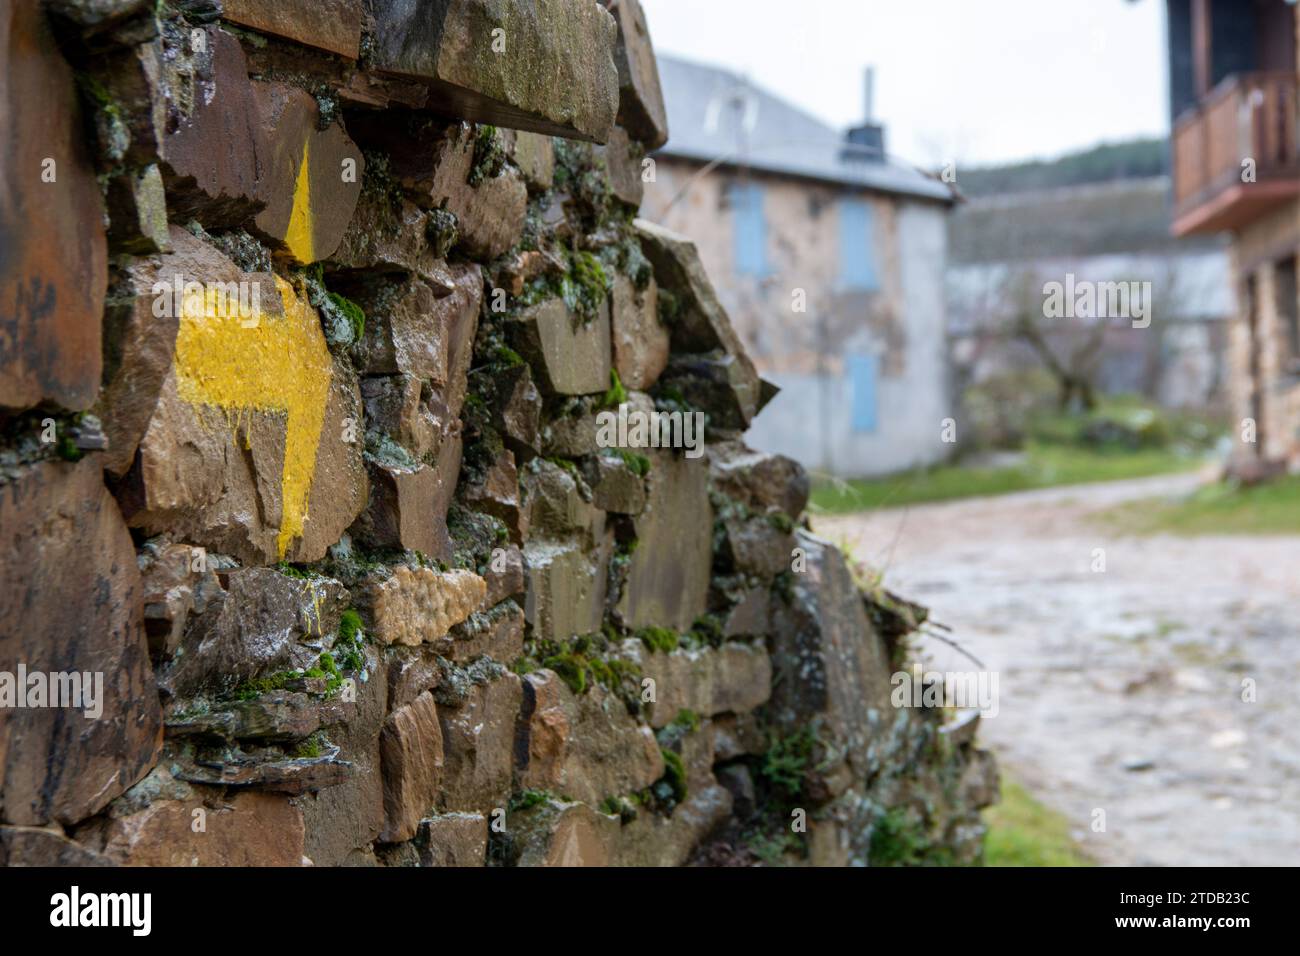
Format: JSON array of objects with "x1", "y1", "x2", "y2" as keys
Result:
[{"x1": 768, "y1": 531, "x2": 893, "y2": 777}]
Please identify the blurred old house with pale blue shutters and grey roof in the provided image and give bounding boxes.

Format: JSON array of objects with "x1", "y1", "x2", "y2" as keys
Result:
[{"x1": 642, "y1": 57, "x2": 954, "y2": 475}]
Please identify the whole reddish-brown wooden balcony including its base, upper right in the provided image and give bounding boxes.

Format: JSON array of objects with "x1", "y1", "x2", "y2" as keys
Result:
[{"x1": 1173, "y1": 73, "x2": 1300, "y2": 235}]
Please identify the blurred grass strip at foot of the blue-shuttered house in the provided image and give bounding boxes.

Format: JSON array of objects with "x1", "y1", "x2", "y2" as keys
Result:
[{"x1": 813, "y1": 441, "x2": 1204, "y2": 514}]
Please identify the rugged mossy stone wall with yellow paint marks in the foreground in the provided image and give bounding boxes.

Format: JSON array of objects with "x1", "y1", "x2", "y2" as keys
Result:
[{"x1": 0, "y1": 0, "x2": 996, "y2": 866}]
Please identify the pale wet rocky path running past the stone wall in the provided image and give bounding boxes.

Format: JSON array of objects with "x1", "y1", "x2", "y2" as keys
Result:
[{"x1": 815, "y1": 475, "x2": 1300, "y2": 865}]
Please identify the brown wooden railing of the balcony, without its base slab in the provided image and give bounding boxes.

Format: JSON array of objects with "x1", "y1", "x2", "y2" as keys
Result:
[{"x1": 1173, "y1": 73, "x2": 1300, "y2": 227}]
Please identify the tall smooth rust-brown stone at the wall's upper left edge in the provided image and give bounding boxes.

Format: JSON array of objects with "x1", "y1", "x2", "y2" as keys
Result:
[{"x1": 0, "y1": 3, "x2": 108, "y2": 410}]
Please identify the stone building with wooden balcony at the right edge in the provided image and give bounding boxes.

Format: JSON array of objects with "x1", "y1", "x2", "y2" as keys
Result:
[{"x1": 1167, "y1": 0, "x2": 1300, "y2": 476}]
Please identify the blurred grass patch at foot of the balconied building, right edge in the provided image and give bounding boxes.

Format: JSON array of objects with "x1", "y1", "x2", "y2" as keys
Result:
[{"x1": 1099, "y1": 476, "x2": 1300, "y2": 535}]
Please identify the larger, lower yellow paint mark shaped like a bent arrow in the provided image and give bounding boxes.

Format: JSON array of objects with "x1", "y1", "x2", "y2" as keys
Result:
[{"x1": 176, "y1": 276, "x2": 334, "y2": 558}]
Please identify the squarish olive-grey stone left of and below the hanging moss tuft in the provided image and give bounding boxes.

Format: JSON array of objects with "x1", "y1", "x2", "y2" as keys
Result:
[{"x1": 507, "y1": 299, "x2": 611, "y2": 395}]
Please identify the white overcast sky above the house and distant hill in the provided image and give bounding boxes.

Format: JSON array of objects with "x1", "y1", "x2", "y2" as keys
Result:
[{"x1": 641, "y1": 0, "x2": 1169, "y2": 166}]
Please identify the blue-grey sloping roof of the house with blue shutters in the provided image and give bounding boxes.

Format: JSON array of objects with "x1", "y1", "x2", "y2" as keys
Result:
[{"x1": 659, "y1": 56, "x2": 957, "y2": 203}]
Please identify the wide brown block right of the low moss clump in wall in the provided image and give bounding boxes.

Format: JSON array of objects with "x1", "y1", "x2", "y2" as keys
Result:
[{"x1": 619, "y1": 640, "x2": 772, "y2": 727}]
